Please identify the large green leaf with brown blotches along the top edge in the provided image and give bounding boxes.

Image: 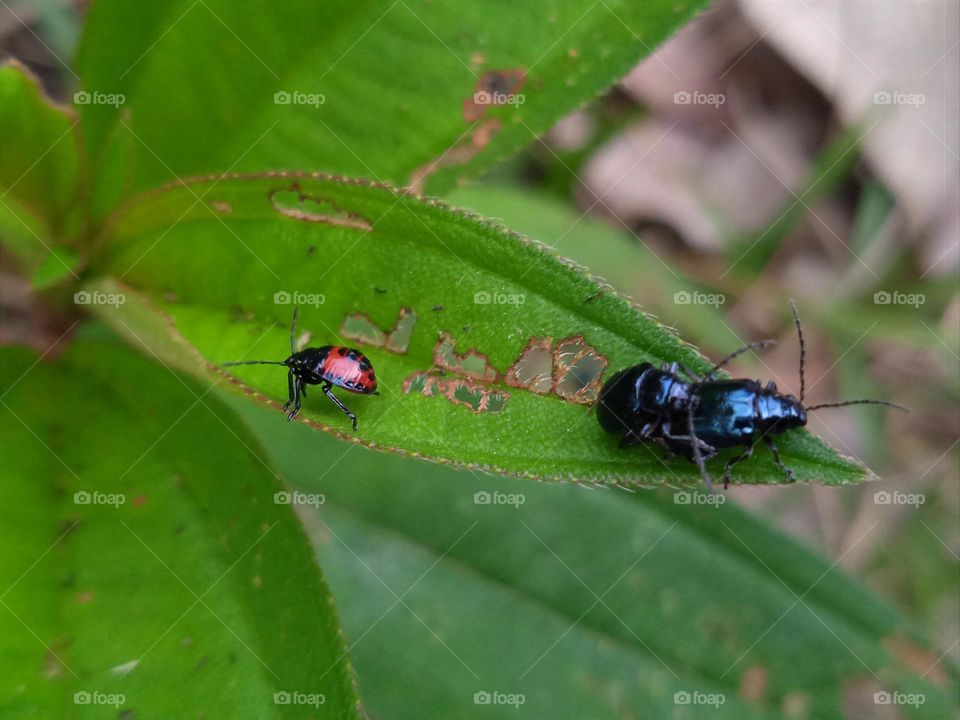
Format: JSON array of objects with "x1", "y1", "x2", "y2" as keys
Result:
[{"x1": 79, "y1": 0, "x2": 704, "y2": 193}]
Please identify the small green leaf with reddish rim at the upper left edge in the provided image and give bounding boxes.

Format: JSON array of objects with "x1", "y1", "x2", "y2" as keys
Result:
[{"x1": 0, "y1": 61, "x2": 80, "y2": 270}]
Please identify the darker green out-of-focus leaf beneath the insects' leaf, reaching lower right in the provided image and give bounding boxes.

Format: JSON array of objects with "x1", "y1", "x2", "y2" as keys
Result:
[{"x1": 231, "y1": 401, "x2": 957, "y2": 720}]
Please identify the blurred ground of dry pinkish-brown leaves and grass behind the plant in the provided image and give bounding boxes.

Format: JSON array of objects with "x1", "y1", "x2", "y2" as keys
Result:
[{"x1": 0, "y1": 0, "x2": 960, "y2": 708}]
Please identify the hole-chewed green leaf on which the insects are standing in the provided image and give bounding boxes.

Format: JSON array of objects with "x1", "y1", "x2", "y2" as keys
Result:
[{"x1": 89, "y1": 174, "x2": 864, "y2": 484}]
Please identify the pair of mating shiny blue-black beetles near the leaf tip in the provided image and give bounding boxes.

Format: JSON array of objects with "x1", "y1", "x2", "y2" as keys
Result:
[{"x1": 597, "y1": 301, "x2": 907, "y2": 489}]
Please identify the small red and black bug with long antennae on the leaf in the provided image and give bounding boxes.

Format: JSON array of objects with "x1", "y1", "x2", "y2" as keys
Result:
[{"x1": 223, "y1": 308, "x2": 380, "y2": 430}]
